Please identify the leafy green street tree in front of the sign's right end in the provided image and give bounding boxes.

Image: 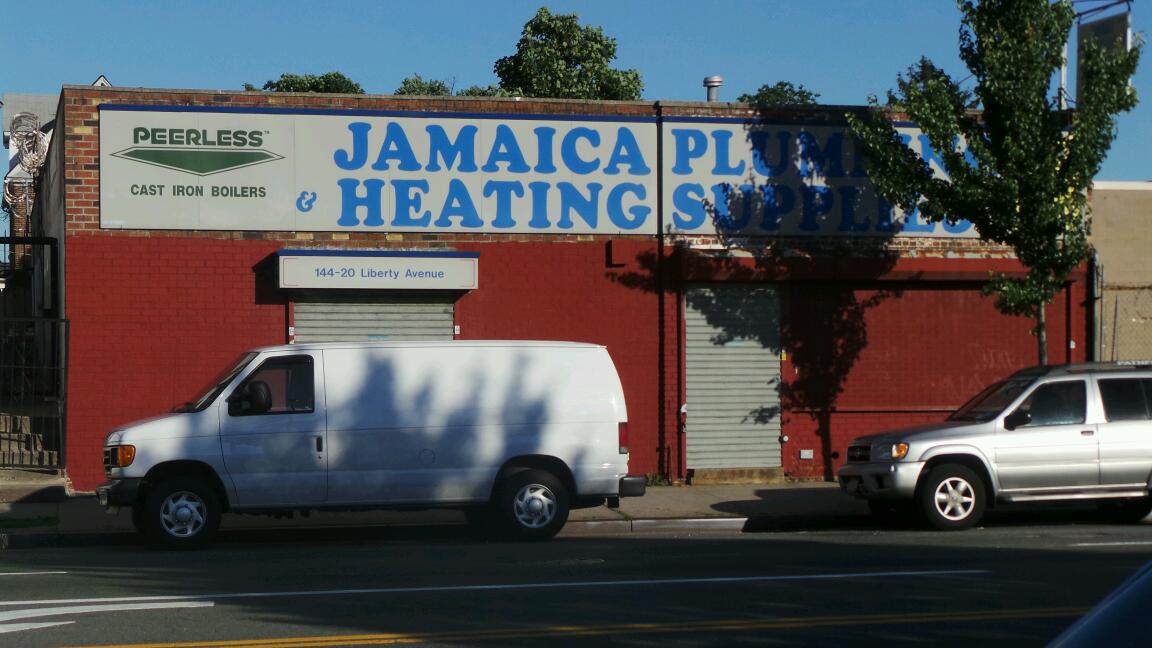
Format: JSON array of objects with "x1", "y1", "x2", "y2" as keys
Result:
[{"x1": 848, "y1": 0, "x2": 1142, "y2": 363}]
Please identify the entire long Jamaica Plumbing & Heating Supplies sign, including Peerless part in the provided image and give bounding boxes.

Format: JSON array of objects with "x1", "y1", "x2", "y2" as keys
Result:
[{"x1": 100, "y1": 104, "x2": 977, "y2": 238}]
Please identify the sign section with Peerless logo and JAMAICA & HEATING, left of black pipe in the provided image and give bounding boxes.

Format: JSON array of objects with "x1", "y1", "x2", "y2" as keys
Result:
[{"x1": 100, "y1": 105, "x2": 657, "y2": 235}]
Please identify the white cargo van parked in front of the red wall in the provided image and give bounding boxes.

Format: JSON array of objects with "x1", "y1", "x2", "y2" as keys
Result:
[{"x1": 97, "y1": 341, "x2": 645, "y2": 548}]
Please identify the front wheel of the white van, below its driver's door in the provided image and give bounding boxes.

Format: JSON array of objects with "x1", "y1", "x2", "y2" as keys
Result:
[{"x1": 141, "y1": 477, "x2": 221, "y2": 549}]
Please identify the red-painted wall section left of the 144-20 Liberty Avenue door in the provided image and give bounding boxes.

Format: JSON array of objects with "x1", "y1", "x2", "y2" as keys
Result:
[{"x1": 66, "y1": 236, "x2": 287, "y2": 490}]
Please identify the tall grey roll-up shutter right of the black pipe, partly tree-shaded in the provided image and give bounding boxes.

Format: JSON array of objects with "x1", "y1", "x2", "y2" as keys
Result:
[{"x1": 684, "y1": 285, "x2": 780, "y2": 469}]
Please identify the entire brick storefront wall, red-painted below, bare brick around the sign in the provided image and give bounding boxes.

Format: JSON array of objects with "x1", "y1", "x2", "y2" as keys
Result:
[{"x1": 59, "y1": 86, "x2": 1086, "y2": 489}]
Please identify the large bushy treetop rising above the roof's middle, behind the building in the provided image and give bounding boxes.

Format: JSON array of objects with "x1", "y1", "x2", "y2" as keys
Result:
[{"x1": 494, "y1": 7, "x2": 644, "y2": 100}]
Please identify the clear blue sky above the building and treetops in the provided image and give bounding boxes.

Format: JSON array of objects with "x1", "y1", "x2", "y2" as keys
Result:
[{"x1": 0, "y1": 0, "x2": 1152, "y2": 180}]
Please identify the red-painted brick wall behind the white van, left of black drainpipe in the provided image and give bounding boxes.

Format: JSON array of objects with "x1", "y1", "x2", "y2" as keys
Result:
[{"x1": 66, "y1": 235, "x2": 660, "y2": 490}]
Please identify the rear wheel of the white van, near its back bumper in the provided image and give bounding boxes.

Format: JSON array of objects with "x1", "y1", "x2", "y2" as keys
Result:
[{"x1": 495, "y1": 470, "x2": 569, "y2": 540}]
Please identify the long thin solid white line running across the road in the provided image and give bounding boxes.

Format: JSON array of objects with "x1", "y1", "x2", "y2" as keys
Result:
[{"x1": 0, "y1": 570, "x2": 992, "y2": 606}]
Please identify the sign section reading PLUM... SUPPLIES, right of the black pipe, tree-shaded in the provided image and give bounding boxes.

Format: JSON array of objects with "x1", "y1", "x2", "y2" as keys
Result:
[{"x1": 661, "y1": 118, "x2": 978, "y2": 238}]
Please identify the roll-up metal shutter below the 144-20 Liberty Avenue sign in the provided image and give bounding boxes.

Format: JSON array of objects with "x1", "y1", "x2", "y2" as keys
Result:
[{"x1": 294, "y1": 295, "x2": 454, "y2": 342}]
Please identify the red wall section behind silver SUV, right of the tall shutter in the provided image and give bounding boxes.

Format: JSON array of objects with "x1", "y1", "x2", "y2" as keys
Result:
[{"x1": 782, "y1": 282, "x2": 1086, "y2": 479}]
